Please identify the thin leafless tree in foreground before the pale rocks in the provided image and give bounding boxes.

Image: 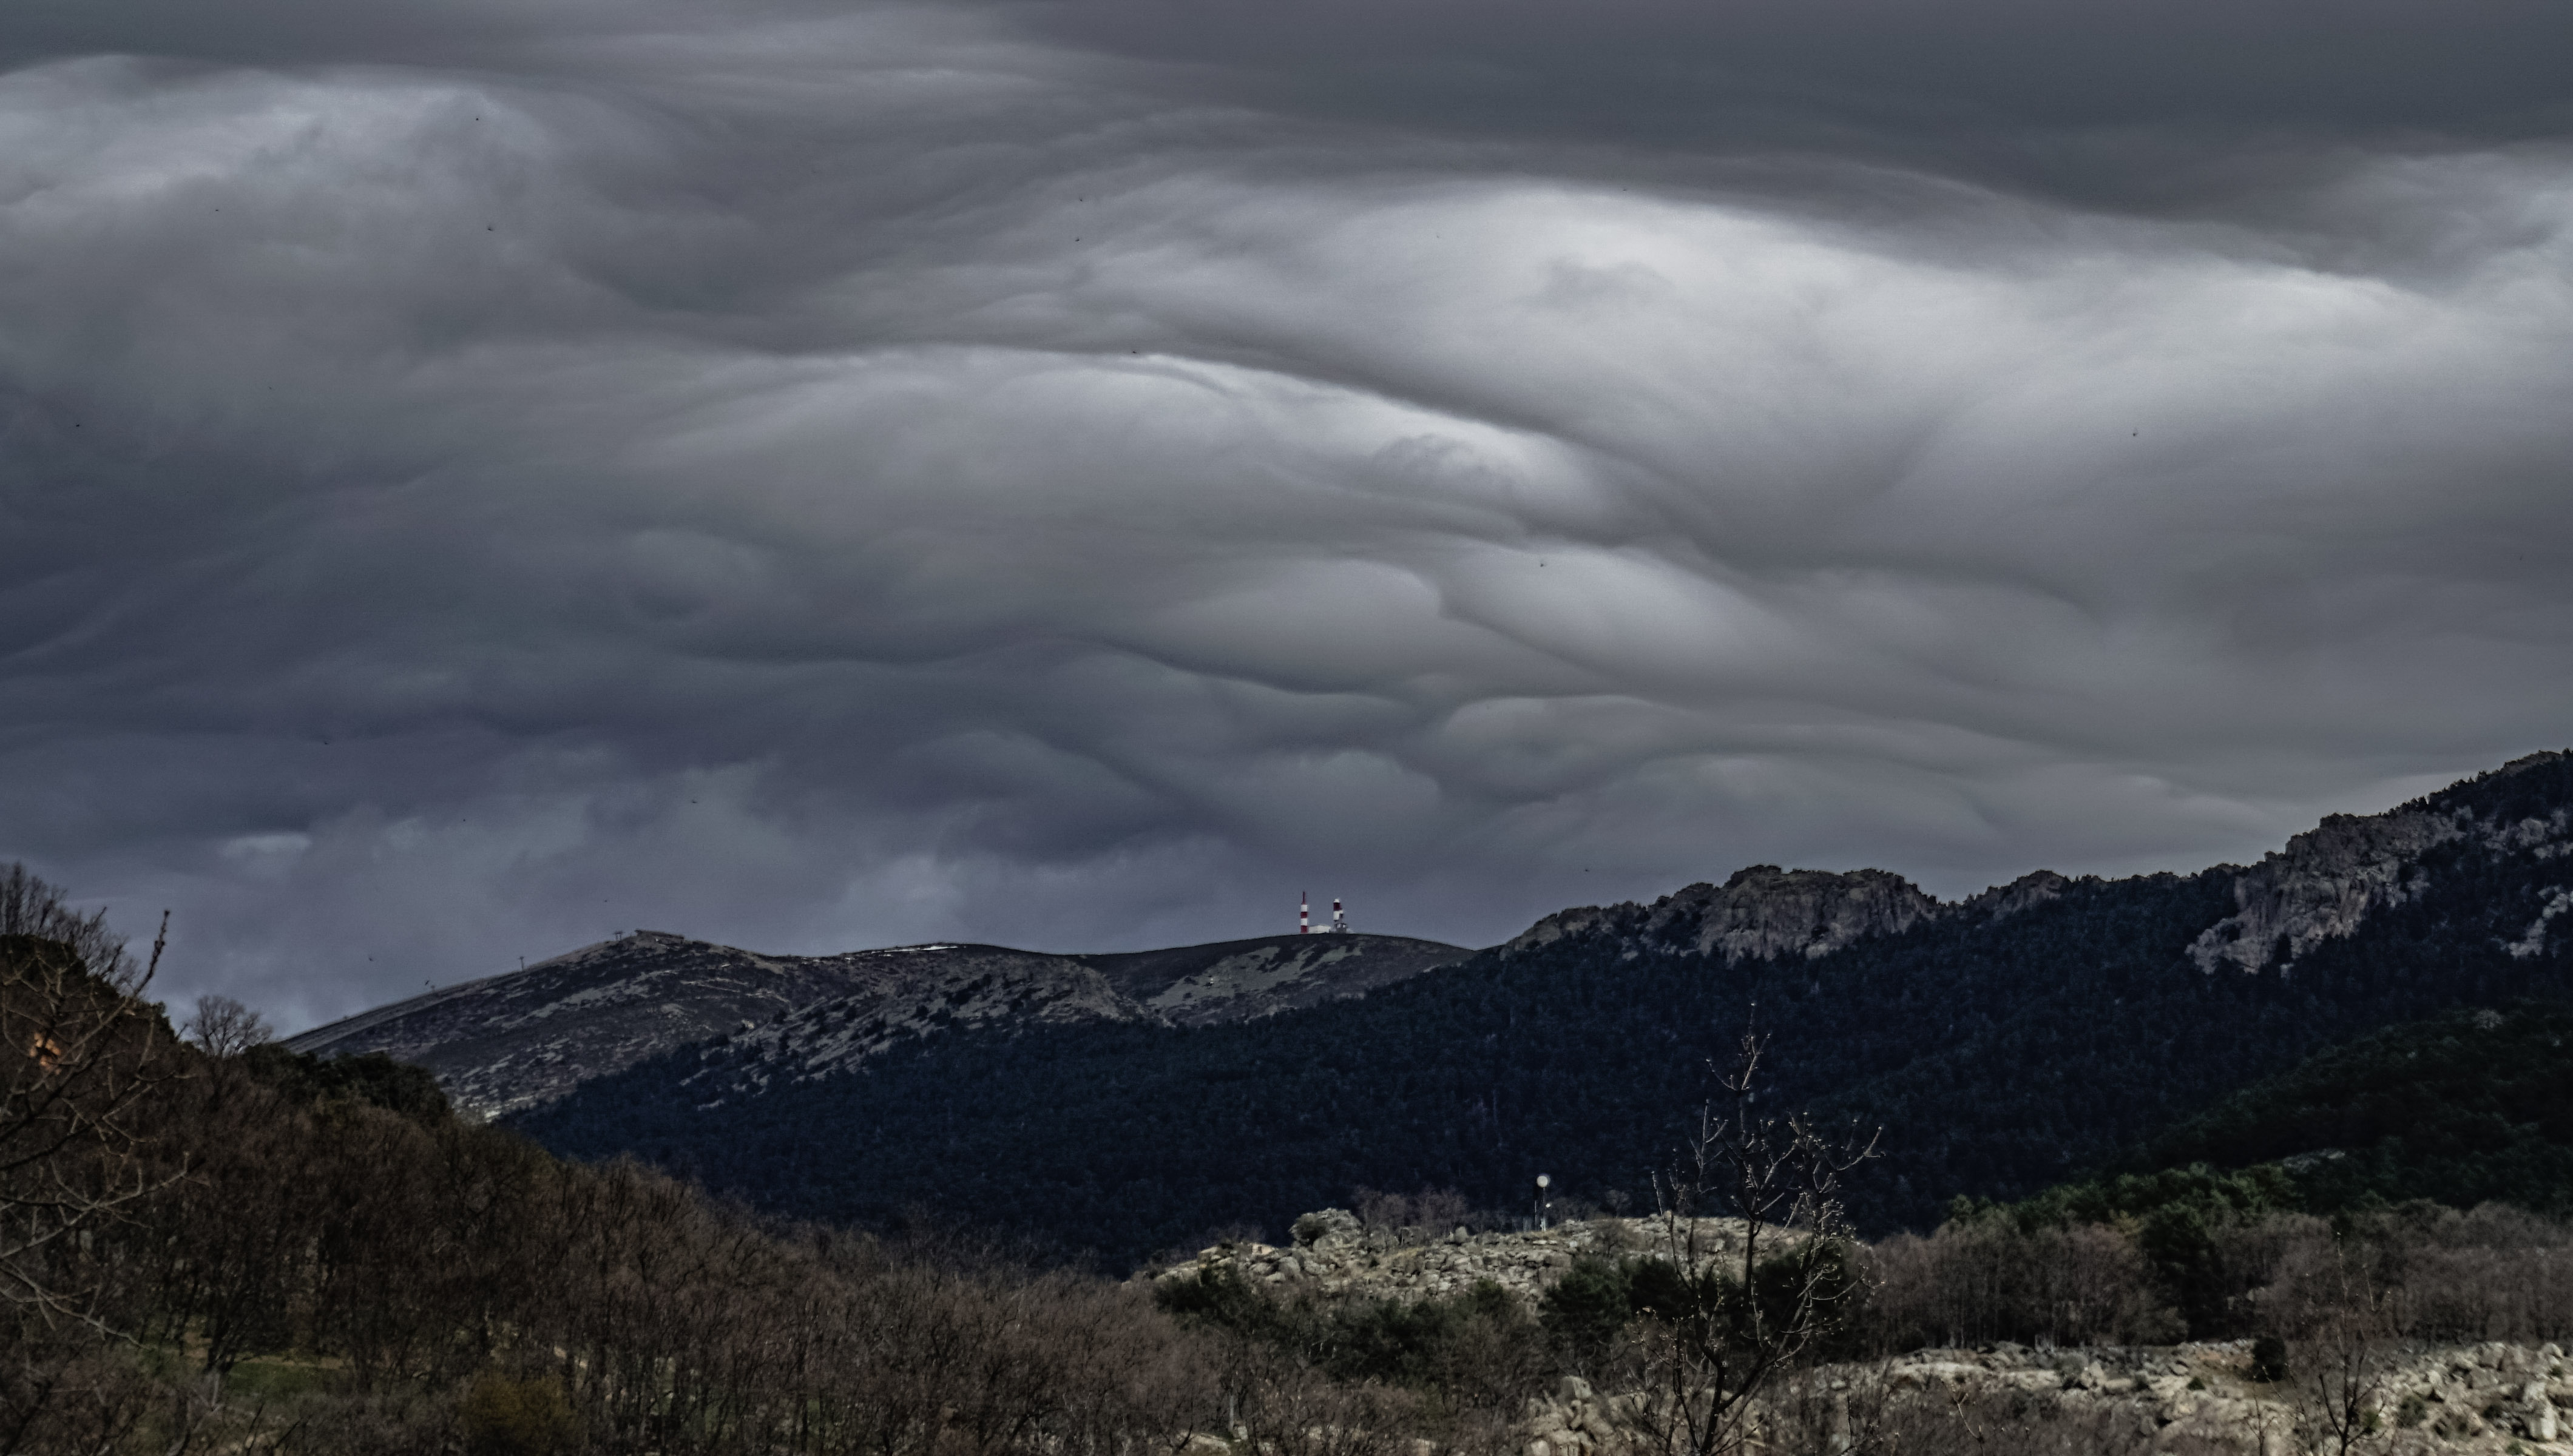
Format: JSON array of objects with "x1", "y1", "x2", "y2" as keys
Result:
[{"x1": 1629, "y1": 1031, "x2": 1876, "y2": 1456}]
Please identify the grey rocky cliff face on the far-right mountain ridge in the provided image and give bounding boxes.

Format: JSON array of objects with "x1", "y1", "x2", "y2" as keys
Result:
[{"x1": 2189, "y1": 753, "x2": 2573, "y2": 972}]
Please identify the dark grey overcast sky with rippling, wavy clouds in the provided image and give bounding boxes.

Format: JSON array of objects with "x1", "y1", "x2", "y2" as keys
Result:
[{"x1": 0, "y1": 0, "x2": 2573, "y2": 1026}]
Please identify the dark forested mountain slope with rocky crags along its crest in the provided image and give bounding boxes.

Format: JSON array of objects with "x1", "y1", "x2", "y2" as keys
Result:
[{"x1": 517, "y1": 753, "x2": 2573, "y2": 1258}]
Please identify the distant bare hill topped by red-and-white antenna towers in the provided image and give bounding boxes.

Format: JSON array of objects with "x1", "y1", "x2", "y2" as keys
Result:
[{"x1": 286, "y1": 931, "x2": 1469, "y2": 1116}]
